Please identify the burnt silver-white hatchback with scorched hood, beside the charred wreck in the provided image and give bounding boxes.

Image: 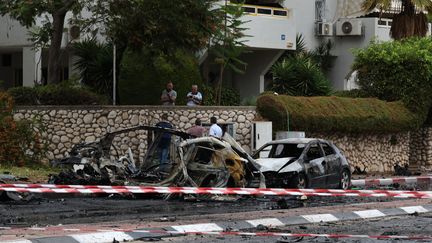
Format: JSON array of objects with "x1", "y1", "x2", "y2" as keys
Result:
[{"x1": 253, "y1": 138, "x2": 351, "y2": 189}]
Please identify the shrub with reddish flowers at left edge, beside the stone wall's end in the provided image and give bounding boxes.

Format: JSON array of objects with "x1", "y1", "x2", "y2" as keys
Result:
[{"x1": 0, "y1": 92, "x2": 46, "y2": 166}]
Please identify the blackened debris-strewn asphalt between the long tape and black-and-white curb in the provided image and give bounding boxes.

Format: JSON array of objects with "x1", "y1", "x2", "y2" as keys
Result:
[{"x1": 0, "y1": 193, "x2": 408, "y2": 227}]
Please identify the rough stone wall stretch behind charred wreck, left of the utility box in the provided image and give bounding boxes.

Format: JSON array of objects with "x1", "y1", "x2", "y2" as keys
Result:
[{"x1": 14, "y1": 106, "x2": 256, "y2": 164}]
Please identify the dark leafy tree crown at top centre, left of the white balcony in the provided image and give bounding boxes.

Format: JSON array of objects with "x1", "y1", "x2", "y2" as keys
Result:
[{"x1": 79, "y1": 0, "x2": 220, "y2": 102}]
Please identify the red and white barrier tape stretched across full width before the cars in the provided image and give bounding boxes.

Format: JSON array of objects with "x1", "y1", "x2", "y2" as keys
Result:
[{"x1": 0, "y1": 184, "x2": 432, "y2": 198}]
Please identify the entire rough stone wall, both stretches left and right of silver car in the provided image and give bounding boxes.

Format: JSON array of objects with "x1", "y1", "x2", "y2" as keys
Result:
[{"x1": 14, "y1": 106, "x2": 432, "y2": 172}]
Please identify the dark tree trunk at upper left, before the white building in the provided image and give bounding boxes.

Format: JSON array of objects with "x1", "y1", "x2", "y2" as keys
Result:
[{"x1": 48, "y1": 11, "x2": 66, "y2": 84}]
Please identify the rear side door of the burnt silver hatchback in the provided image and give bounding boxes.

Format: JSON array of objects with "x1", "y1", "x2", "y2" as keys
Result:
[{"x1": 320, "y1": 141, "x2": 342, "y2": 187}]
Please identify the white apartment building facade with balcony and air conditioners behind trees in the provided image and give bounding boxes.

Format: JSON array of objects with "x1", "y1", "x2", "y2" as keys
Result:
[{"x1": 0, "y1": 0, "x2": 398, "y2": 98}]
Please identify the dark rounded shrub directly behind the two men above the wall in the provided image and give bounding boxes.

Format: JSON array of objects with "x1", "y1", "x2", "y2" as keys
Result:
[{"x1": 119, "y1": 50, "x2": 202, "y2": 105}]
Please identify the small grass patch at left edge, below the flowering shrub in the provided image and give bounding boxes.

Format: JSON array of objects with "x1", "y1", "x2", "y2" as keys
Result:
[{"x1": 0, "y1": 165, "x2": 61, "y2": 182}]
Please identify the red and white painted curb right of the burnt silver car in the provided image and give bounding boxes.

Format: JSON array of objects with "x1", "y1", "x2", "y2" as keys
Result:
[{"x1": 351, "y1": 176, "x2": 432, "y2": 186}]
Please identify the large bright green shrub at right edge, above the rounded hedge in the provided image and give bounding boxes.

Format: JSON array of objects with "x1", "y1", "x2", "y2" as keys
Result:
[{"x1": 353, "y1": 38, "x2": 432, "y2": 114}]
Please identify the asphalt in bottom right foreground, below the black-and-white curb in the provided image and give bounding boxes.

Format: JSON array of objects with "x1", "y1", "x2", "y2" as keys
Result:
[{"x1": 154, "y1": 213, "x2": 432, "y2": 243}]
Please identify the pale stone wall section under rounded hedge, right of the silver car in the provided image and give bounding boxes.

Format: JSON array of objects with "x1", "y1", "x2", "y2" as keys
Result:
[{"x1": 308, "y1": 132, "x2": 411, "y2": 172}]
